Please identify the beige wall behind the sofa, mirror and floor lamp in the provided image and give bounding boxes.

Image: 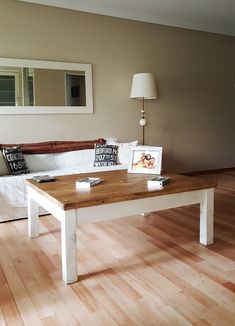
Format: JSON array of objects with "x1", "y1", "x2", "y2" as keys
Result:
[{"x1": 0, "y1": 0, "x2": 235, "y2": 171}]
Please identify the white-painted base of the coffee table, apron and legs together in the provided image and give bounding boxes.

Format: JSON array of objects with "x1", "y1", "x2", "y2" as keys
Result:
[{"x1": 27, "y1": 186, "x2": 214, "y2": 284}]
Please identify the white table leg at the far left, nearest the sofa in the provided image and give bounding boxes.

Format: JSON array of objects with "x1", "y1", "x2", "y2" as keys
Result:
[{"x1": 28, "y1": 192, "x2": 39, "y2": 238}]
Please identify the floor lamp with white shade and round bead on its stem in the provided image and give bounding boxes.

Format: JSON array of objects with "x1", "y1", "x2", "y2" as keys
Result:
[{"x1": 130, "y1": 73, "x2": 157, "y2": 145}]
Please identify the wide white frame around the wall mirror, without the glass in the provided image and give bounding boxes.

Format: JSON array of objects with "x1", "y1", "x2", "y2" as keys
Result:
[{"x1": 0, "y1": 58, "x2": 93, "y2": 114}]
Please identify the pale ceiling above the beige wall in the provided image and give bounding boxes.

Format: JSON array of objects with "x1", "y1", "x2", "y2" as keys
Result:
[{"x1": 19, "y1": 0, "x2": 235, "y2": 36}]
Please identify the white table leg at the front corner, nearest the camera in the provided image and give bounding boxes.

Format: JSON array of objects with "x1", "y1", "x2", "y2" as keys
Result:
[{"x1": 61, "y1": 210, "x2": 78, "y2": 284}]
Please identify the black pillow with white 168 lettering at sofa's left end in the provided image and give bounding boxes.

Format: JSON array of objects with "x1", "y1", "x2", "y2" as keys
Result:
[{"x1": 2, "y1": 146, "x2": 29, "y2": 175}]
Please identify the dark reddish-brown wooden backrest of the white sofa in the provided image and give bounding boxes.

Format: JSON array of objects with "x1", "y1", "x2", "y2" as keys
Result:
[{"x1": 0, "y1": 138, "x2": 105, "y2": 154}]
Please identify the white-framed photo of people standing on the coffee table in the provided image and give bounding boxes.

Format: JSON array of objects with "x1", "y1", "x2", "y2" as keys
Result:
[{"x1": 128, "y1": 146, "x2": 162, "y2": 174}]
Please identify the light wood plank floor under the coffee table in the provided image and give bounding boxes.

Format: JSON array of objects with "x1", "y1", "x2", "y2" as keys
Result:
[{"x1": 0, "y1": 172, "x2": 235, "y2": 326}]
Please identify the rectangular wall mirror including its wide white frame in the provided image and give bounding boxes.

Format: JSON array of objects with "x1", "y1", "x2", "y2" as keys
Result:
[{"x1": 0, "y1": 58, "x2": 93, "y2": 114}]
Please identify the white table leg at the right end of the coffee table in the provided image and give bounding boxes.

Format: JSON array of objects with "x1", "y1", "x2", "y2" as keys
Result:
[{"x1": 200, "y1": 188, "x2": 214, "y2": 245}]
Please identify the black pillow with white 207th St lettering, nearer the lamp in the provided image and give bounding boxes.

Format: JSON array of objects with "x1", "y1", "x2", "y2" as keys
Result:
[{"x1": 94, "y1": 144, "x2": 118, "y2": 167}]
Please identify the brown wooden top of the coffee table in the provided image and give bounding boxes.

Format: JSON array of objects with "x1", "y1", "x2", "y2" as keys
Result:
[{"x1": 26, "y1": 170, "x2": 216, "y2": 210}]
